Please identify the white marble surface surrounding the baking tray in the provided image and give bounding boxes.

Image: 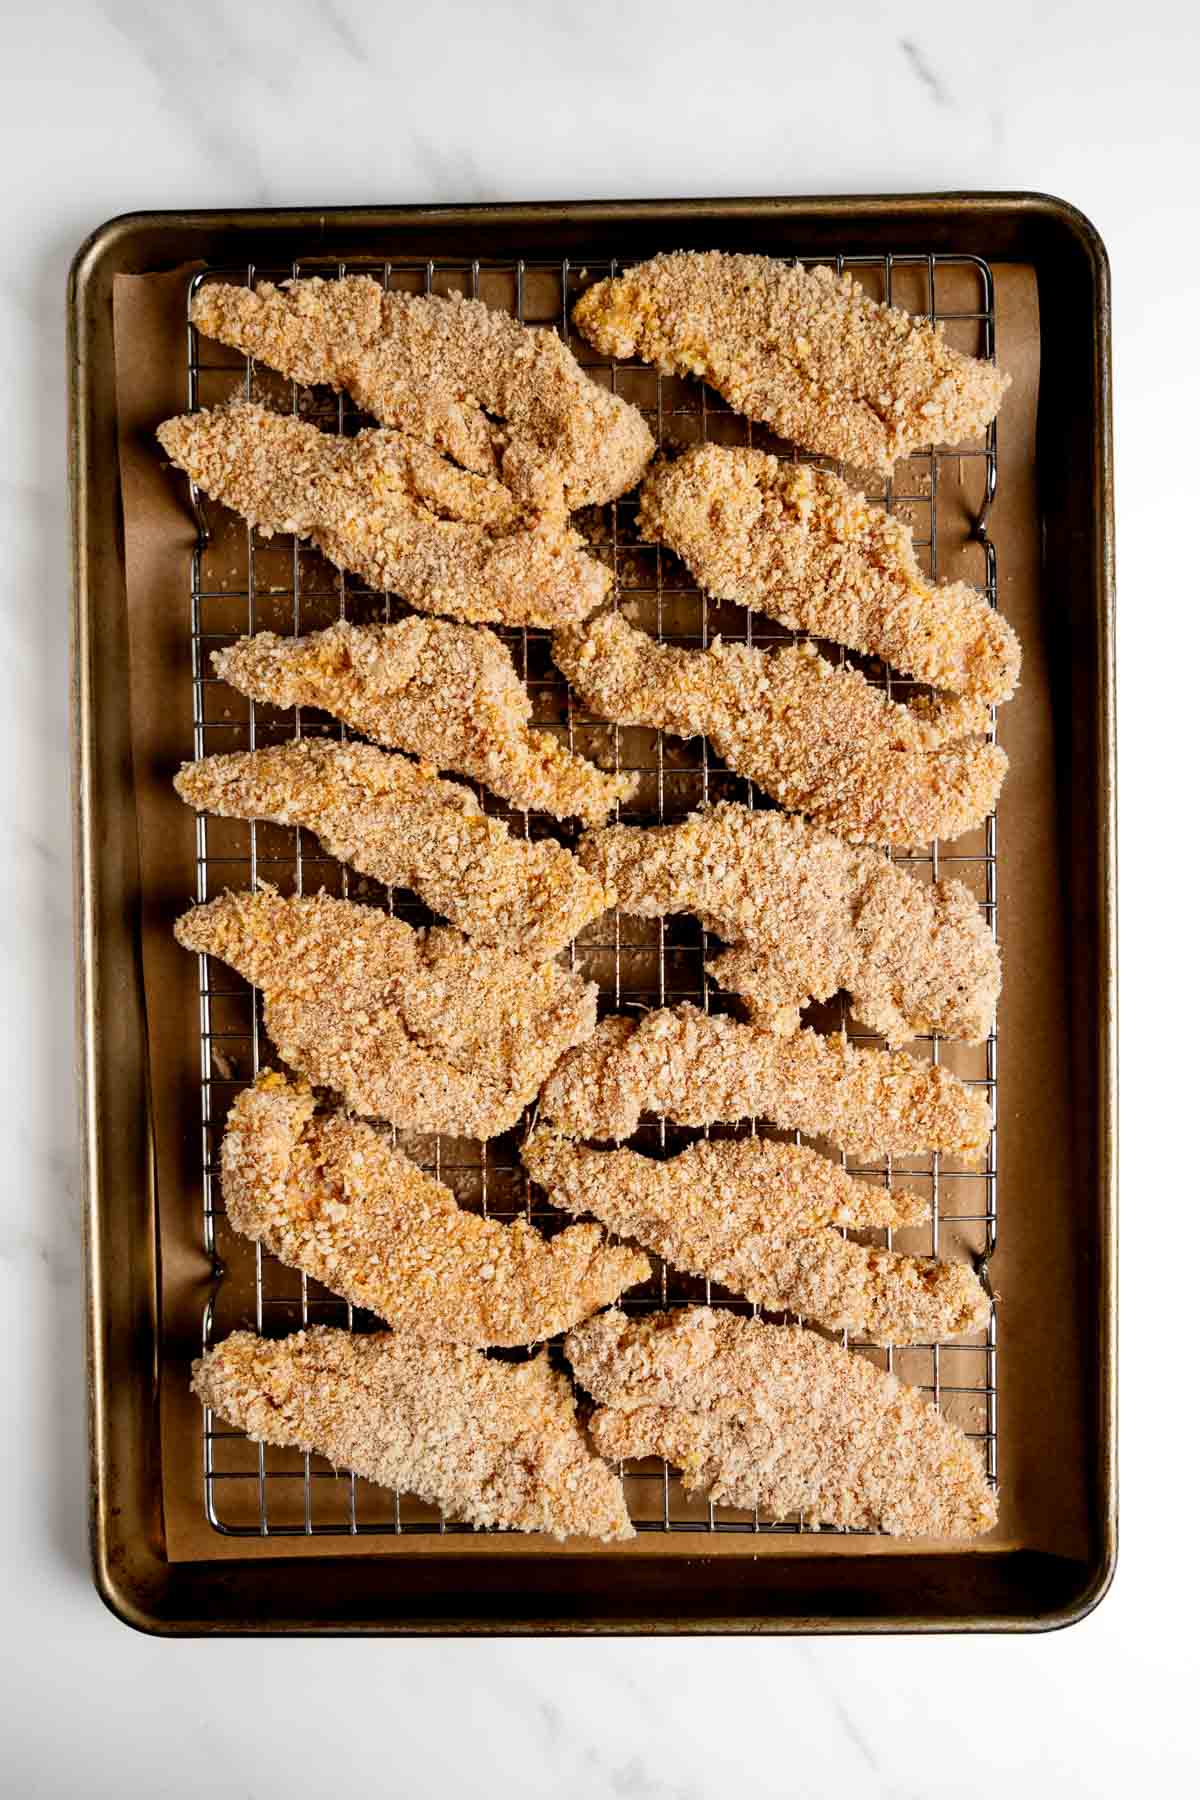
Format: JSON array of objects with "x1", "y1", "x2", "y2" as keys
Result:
[{"x1": 0, "y1": 0, "x2": 1200, "y2": 1800}]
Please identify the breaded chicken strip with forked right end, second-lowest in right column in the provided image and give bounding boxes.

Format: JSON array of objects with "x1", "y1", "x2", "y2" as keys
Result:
[{"x1": 522, "y1": 1127, "x2": 990, "y2": 1345}]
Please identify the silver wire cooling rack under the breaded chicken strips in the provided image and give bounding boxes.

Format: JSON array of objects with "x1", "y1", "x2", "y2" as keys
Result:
[{"x1": 185, "y1": 245, "x2": 999, "y2": 1537}]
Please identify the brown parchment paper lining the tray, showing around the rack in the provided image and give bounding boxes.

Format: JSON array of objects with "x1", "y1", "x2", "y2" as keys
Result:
[{"x1": 113, "y1": 265, "x2": 1087, "y2": 1561}]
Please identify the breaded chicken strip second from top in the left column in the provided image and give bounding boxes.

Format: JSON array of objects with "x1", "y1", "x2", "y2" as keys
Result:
[{"x1": 158, "y1": 400, "x2": 612, "y2": 625}]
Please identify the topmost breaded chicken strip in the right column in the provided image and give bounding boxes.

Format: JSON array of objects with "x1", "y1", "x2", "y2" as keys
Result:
[{"x1": 574, "y1": 250, "x2": 1011, "y2": 475}]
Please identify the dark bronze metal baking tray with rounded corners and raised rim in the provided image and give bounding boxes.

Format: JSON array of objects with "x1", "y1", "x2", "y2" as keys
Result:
[{"x1": 70, "y1": 196, "x2": 1115, "y2": 1633}]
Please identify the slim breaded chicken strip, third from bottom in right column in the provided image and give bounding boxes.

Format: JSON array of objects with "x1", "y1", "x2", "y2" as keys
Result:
[{"x1": 538, "y1": 1004, "x2": 991, "y2": 1159}]
